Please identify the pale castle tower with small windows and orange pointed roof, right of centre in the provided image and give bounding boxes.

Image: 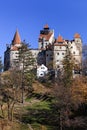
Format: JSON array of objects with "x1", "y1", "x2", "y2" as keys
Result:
[{"x1": 53, "y1": 35, "x2": 67, "y2": 70}]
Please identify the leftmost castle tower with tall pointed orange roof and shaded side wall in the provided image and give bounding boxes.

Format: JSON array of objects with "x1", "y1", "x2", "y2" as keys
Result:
[{"x1": 4, "y1": 30, "x2": 21, "y2": 70}]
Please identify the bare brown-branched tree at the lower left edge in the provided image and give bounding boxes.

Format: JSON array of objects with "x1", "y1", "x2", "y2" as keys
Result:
[{"x1": 0, "y1": 70, "x2": 21, "y2": 121}]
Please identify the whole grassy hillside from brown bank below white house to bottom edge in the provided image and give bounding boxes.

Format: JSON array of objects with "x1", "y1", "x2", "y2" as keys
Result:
[{"x1": 0, "y1": 81, "x2": 55, "y2": 130}]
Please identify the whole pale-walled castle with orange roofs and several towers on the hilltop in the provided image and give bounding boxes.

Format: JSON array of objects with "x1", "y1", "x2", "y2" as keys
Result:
[{"x1": 4, "y1": 24, "x2": 82, "y2": 73}]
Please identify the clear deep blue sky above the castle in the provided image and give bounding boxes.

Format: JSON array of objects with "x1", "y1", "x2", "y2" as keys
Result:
[{"x1": 0, "y1": 0, "x2": 87, "y2": 61}]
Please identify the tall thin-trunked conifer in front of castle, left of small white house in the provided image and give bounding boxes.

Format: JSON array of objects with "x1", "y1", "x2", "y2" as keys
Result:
[{"x1": 16, "y1": 42, "x2": 35, "y2": 103}]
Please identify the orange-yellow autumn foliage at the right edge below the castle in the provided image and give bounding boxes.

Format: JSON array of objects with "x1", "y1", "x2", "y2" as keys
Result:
[{"x1": 70, "y1": 77, "x2": 87, "y2": 103}]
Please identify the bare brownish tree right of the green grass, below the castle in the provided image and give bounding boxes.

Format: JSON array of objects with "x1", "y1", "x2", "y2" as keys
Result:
[{"x1": 53, "y1": 81, "x2": 71, "y2": 130}]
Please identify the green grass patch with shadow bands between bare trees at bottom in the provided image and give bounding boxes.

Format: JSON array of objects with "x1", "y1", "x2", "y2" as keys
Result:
[{"x1": 18, "y1": 94, "x2": 57, "y2": 130}]
